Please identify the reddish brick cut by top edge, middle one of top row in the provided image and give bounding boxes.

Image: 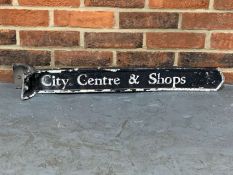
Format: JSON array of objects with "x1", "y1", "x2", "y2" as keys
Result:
[{"x1": 85, "y1": 0, "x2": 144, "y2": 8}]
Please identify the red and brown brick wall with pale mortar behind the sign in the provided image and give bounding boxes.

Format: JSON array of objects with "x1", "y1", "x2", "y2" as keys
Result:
[{"x1": 0, "y1": 0, "x2": 233, "y2": 84}]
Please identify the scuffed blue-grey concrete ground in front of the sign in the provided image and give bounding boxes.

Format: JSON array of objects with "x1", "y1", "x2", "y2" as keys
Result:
[{"x1": 0, "y1": 84, "x2": 233, "y2": 175}]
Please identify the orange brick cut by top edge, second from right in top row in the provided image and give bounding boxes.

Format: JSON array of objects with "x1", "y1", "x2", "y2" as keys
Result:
[{"x1": 149, "y1": 0, "x2": 209, "y2": 9}]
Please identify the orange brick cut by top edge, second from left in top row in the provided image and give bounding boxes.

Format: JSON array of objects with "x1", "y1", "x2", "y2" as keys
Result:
[{"x1": 18, "y1": 0, "x2": 80, "y2": 7}]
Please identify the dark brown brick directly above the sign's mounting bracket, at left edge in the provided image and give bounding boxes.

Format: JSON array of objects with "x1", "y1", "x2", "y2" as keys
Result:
[{"x1": 0, "y1": 49, "x2": 51, "y2": 66}]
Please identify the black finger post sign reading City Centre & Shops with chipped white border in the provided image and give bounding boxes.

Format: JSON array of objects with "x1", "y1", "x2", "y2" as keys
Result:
[{"x1": 14, "y1": 64, "x2": 224, "y2": 100}]
